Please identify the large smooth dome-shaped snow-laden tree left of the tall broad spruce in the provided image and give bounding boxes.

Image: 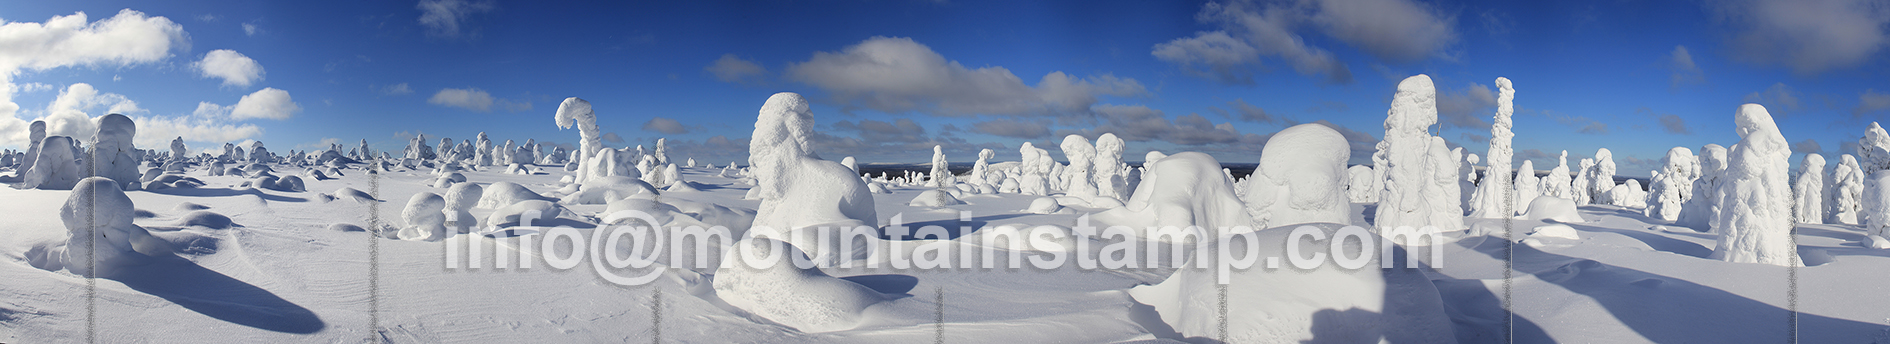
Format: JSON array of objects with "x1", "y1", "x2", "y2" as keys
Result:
[{"x1": 1246, "y1": 123, "x2": 1353, "y2": 227}]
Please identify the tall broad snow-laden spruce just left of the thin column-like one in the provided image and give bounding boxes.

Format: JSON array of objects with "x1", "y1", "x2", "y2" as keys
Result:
[{"x1": 1383, "y1": 74, "x2": 1463, "y2": 231}]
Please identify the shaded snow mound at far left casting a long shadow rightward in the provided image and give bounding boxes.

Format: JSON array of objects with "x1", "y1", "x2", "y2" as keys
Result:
[{"x1": 59, "y1": 178, "x2": 170, "y2": 276}]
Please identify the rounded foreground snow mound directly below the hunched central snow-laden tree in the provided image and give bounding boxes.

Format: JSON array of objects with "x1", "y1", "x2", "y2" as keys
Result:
[{"x1": 713, "y1": 238, "x2": 886, "y2": 333}]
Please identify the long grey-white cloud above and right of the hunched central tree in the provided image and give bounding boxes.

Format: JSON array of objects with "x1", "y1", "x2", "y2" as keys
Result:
[{"x1": 786, "y1": 38, "x2": 1147, "y2": 115}]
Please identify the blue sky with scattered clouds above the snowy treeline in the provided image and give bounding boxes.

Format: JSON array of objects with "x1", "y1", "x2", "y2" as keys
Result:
[{"x1": 0, "y1": 0, "x2": 1890, "y2": 176}]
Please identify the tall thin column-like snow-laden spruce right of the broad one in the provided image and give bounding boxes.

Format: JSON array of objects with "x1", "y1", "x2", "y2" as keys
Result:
[{"x1": 1470, "y1": 77, "x2": 1527, "y2": 219}]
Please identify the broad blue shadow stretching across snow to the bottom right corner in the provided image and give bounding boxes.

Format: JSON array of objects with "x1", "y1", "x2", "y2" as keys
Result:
[{"x1": 1472, "y1": 233, "x2": 1884, "y2": 342}]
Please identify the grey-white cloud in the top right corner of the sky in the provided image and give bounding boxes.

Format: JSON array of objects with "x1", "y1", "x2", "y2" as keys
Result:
[{"x1": 1705, "y1": 0, "x2": 1890, "y2": 76}]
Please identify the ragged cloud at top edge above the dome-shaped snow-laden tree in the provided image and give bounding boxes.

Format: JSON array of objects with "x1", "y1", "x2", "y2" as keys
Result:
[{"x1": 1151, "y1": 0, "x2": 1457, "y2": 85}]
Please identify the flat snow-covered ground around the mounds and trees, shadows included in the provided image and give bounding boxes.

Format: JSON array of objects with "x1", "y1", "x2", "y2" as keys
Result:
[{"x1": 0, "y1": 162, "x2": 1890, "y2": 342}]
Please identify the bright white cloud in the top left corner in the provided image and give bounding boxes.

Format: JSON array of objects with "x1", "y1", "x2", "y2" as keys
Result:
[{"x1": 0, "y1": 9, "x2": 189, "y2": 146}]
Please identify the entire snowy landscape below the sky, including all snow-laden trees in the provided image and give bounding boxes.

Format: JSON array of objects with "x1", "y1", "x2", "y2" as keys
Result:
[{"x1": 0, "y1": 89, "x2": 1890, "y2": 342}]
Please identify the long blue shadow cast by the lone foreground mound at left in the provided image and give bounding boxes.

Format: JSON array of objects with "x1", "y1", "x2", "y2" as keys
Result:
[{"x1": 110, "y1": 259, "x2": 327, "y2": 335}]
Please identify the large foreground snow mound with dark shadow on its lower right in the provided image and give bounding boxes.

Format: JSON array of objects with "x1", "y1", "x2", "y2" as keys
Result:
[{"x1": 1128, "y1": 222, "x2": 1455, "y2": 342}]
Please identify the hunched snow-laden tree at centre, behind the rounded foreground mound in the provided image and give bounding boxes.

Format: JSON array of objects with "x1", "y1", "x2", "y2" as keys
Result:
[{"x1": 748, "y1": 93, "x2": 879, "y2": 233}]
